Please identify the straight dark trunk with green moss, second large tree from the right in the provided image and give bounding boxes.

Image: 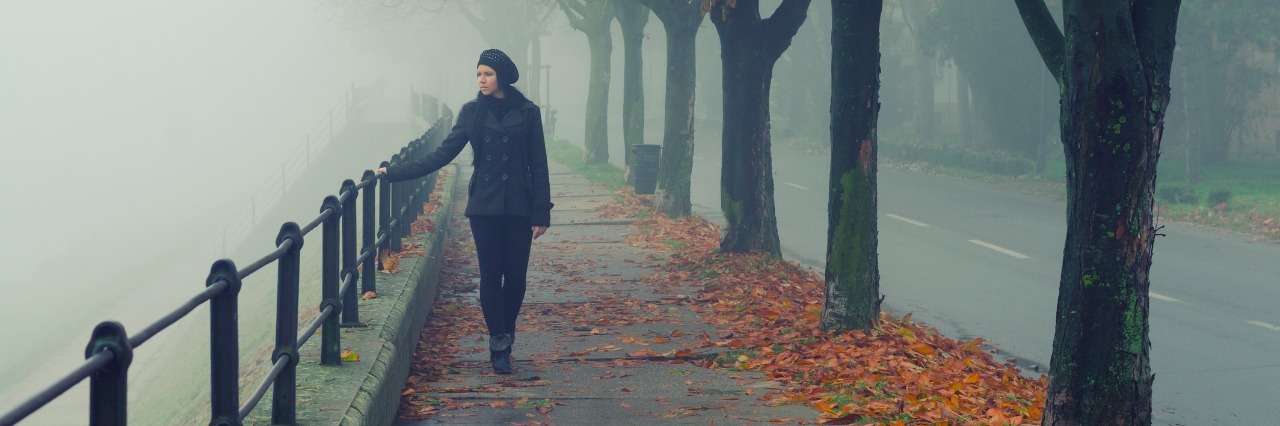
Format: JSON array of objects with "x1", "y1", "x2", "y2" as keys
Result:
[{"x1": 822, "y1": 0, "x2": 880, "y2": 330}]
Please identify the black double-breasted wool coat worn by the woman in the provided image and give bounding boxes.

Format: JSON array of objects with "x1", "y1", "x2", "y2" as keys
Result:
[{"x1": 387, "y1": 100, "x2": 554, "y2": 226}]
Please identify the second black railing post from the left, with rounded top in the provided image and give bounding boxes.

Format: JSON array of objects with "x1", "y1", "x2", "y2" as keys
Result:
[{"x1": 205, "y1": 258, "x2": 241, "y2": 426}]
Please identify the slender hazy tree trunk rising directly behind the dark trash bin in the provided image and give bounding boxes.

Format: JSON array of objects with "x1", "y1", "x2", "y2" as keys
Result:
[{"x1": 613, "y1": 1, "x2": 649, "y2": 183}]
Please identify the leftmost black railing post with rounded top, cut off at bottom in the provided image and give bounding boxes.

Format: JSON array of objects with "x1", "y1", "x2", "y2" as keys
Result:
[{"x1": 84, "y1": 321, "x2": 133, "y2": 425}]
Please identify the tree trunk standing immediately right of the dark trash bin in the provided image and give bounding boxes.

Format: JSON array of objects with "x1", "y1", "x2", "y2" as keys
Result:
[{"x1": 639, "y1": 0, "x2": 704, "y2": 217}]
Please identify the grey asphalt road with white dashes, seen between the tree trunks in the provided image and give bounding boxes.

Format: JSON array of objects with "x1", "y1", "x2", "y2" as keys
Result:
[{"x1": 675, "y1": 138, "x2": 1280, "y2": 425}]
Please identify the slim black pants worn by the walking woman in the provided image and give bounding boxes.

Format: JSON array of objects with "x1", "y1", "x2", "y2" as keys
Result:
[{"x1": 470, "y1": 216, "x2": 534, "y2": 336}]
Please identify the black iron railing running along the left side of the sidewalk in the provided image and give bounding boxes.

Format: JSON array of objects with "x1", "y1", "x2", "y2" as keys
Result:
[{"x1": 0, "y1": 109, "x2": 453, "y2": 426}]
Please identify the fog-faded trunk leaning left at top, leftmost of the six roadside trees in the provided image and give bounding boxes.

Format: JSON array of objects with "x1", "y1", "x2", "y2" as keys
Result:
[{"x1": 557, "y1": 0, "x2": 614, "y2": 164}]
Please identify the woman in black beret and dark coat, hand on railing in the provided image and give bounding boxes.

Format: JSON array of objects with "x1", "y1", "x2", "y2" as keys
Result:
[{"x1": 376, "y1": 49, "x2": 553, "y2": 374}]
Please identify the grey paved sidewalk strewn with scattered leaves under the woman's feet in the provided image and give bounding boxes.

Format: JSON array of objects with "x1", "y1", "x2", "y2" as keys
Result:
[{"x1": 396, "y1": 164, "x2": 817, "y2": 425}]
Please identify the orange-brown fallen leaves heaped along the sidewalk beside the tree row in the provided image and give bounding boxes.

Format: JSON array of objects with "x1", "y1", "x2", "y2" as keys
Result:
[{"x1": 611, "y1": 201, "x2": 1046, "y2": 425}]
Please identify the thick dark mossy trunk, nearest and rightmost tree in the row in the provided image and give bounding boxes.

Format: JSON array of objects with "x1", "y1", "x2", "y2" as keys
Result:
[{"x1": 1016, "y1": 0, "x2": 1180, "y2": 425}]
